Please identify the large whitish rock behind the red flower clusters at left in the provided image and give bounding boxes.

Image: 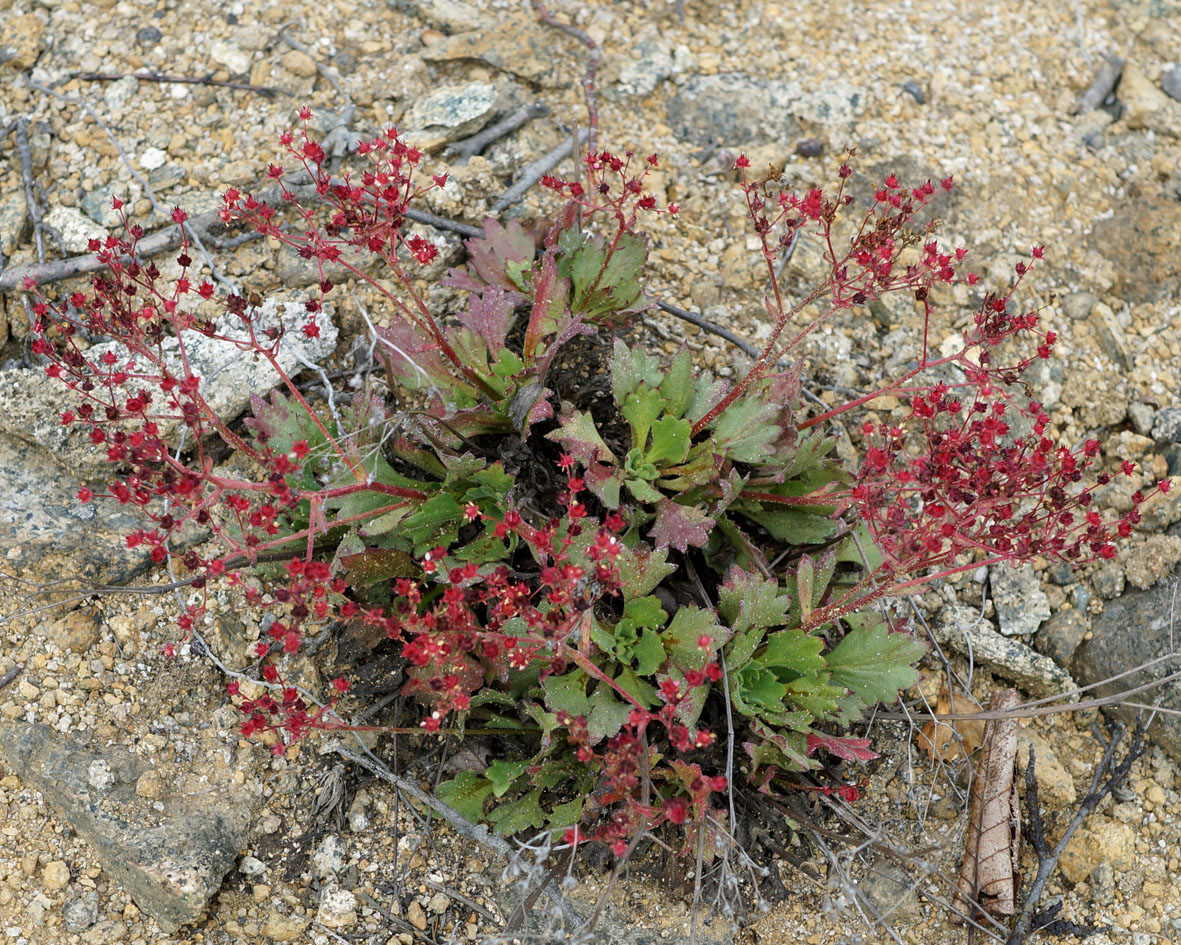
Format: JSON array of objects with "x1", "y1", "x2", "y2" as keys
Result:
[{"x1": 0, "y1": 298, "x2": 337, "y2": 477}]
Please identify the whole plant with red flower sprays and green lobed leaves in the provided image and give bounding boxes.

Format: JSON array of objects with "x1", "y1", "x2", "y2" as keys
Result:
[{"x1": 25, "y1": 111, "x2": 1167, "y2": 855}]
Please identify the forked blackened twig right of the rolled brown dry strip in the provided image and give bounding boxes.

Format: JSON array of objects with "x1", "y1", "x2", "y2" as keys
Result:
[{"x1": 1006, "y1": 712, "x2": 1148, "y2": 945}]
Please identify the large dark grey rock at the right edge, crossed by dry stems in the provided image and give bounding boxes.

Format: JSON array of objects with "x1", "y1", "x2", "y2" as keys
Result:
[{"x1": 1072, "y1": 572, "x2": 1181, "y2": 761}]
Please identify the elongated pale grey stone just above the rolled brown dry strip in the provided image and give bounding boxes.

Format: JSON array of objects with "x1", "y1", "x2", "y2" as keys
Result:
[{"x1": 932, "y1": 605, "x2": 1077, "y2": 696}]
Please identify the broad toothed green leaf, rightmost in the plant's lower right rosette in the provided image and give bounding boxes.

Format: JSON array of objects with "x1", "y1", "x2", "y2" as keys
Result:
[{"x1": 827, "y1": 611, "x2": 927, "y2": 704}]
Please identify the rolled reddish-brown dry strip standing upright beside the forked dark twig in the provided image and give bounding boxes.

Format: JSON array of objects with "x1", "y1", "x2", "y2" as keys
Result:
[{"x1": 951, "y1": 689, "x2": 1020, "y2": 925}]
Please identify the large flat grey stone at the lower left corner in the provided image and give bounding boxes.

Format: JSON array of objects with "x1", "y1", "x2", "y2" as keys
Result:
[{"x1": 0, "y1": 723, "x2": 249, "y2": 933}]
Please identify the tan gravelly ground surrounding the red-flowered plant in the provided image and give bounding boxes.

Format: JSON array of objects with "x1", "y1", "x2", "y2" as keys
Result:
[{"x1": 0, "y1": 0, "x2": 1181, "y2": 945}]
